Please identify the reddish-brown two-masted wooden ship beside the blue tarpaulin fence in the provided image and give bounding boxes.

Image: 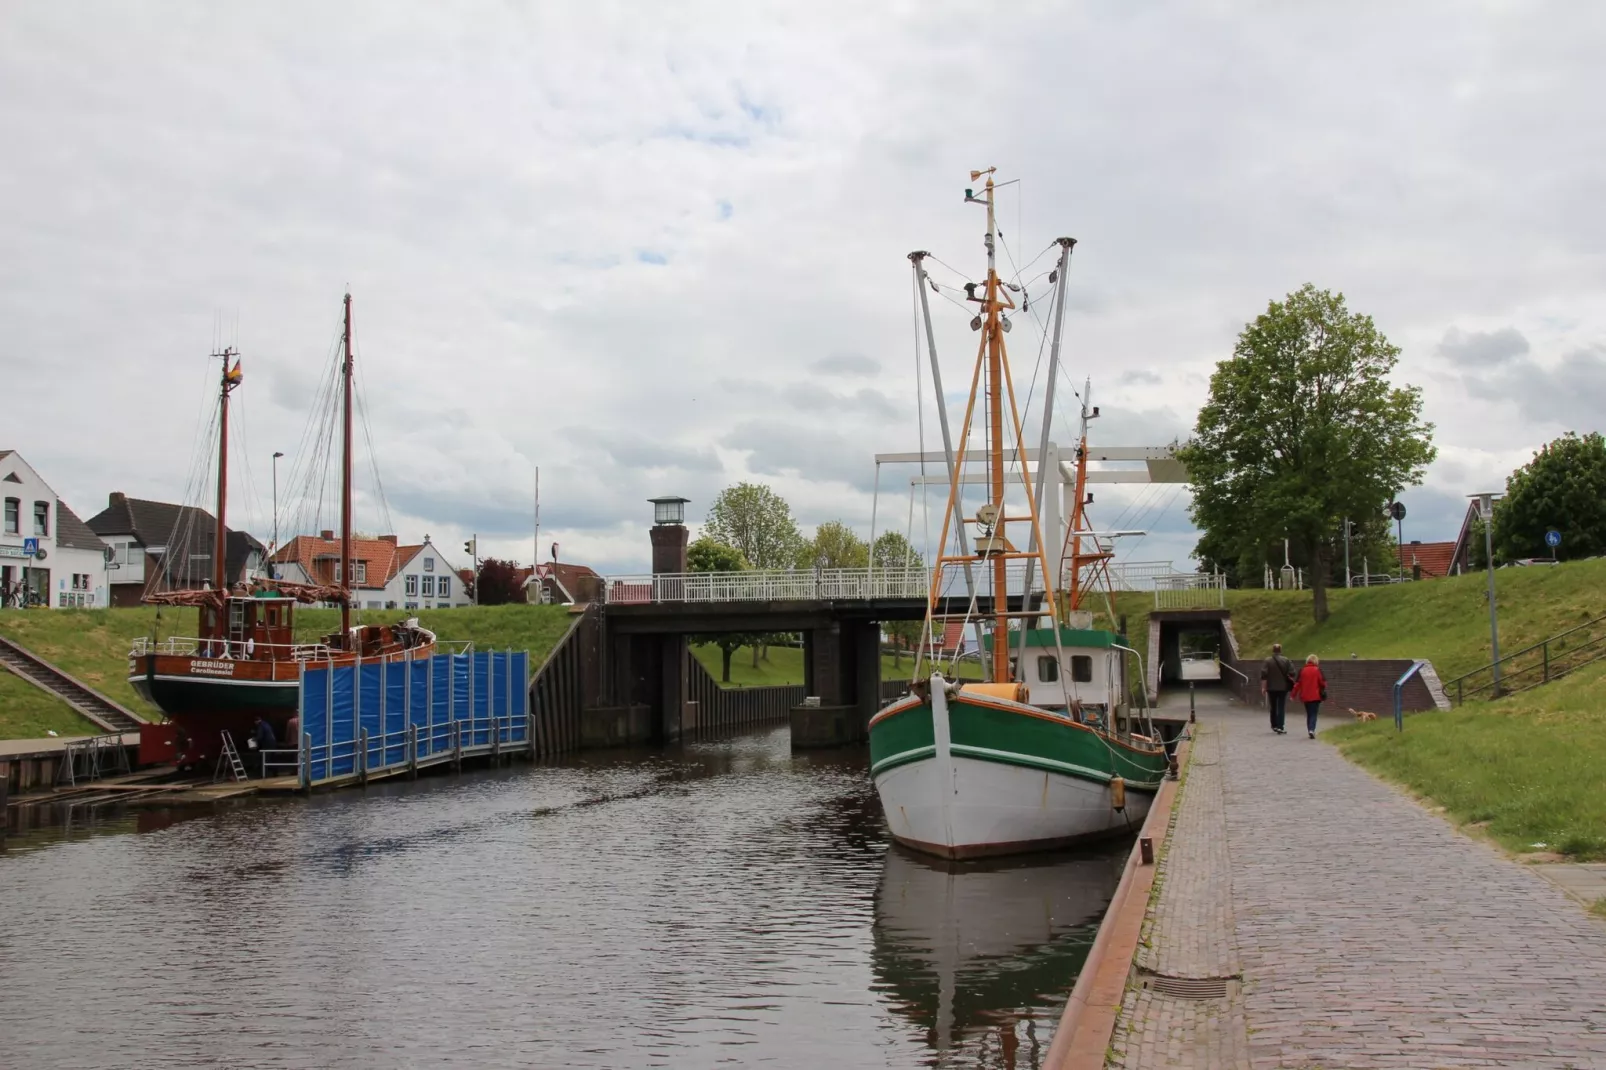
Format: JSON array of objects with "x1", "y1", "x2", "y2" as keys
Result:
[{"x1": 128, "y1": 294, "x2": 435, "y2": 766}]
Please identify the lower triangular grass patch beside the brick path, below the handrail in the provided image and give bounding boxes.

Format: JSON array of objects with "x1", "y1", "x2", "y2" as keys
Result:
[{"x1": 1325, "y1": 662, "x2": 1606, "y2": 861}]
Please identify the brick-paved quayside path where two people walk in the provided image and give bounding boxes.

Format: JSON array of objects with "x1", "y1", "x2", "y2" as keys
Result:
[{"x1": 1111, "y1": 690, "x2": 1606, "y2": 1070}]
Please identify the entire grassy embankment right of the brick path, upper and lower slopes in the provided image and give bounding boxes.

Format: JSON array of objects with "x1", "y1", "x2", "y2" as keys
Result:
[{"x1": 1229, "y1": 561, "x2": 1606, "y2": 860}]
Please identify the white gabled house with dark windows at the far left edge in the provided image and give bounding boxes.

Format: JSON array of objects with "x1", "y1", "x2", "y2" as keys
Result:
[{"x1": 0, "y1": 450, "x2": 109, "y2": 609}]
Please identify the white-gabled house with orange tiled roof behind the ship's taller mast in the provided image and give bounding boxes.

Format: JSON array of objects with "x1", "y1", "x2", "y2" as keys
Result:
[{"x1": 271, "y1": 532, "x2": 471, "y2": 609}]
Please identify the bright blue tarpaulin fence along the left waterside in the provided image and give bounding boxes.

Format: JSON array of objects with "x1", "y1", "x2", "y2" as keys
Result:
[{"x1": 300, "y1": 651, "x2": 530, "y2": 786}]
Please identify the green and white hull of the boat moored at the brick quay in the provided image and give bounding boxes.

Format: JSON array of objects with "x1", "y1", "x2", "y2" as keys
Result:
[{"x1": 870, "y1": 681, "x2": 1168, "y2": 858}]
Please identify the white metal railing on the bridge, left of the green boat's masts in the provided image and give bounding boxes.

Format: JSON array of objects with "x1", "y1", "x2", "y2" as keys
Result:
[{"x1": 604, "y1": 567, "x2": 931, "y2": 604}]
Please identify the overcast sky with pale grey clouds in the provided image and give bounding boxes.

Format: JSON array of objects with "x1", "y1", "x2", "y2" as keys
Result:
[{"x1": 0, "y1": 0, "x2": 1606, "y2": 570}]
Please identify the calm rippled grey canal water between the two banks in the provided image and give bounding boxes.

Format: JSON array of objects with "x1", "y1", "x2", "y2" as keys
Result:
[{"x1": 0, "y1": 728, "x2": 1124, "y2": 1070}]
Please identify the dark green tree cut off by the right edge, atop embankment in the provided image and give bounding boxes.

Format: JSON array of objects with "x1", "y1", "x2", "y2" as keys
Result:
[{"x1": 1478, "y1": 431, "x2": 1606, "y2": 561}]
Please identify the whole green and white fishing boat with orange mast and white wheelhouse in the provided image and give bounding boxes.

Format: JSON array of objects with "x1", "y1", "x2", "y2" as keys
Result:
[{"x1": 869, "y1": 169, "x2": 1169, "y2": 858}]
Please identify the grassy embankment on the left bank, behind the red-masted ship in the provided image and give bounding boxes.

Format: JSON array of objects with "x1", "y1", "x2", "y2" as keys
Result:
[{"x1": 0, "y1": 606, "x2": 572, "y2": 739}]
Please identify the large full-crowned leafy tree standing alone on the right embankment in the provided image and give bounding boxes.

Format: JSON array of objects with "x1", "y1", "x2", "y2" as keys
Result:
[{"x1": 1180, "y1": 283, "x2": 1436, "y2": 622}]
